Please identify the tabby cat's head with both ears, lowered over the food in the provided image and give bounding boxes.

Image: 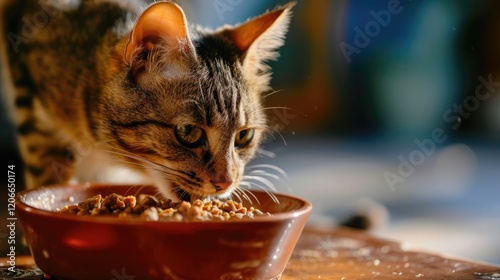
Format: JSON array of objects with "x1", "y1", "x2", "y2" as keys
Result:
[{"x1": 100, "y1": 2, "x2": 293, "y2": 198}]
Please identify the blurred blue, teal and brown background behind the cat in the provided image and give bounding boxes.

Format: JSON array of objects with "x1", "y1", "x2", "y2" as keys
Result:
[{"x1": 0, "y1": 0, "x2": 500, "y2": 264}]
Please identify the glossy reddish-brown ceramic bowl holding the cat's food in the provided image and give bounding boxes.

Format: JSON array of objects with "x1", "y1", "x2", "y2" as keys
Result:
[{"x1": 16, "y1": 184, "x2": 312, "y2": 280}]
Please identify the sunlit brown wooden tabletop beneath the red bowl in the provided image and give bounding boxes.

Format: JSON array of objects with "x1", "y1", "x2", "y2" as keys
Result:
[{"x1": 0, "y1": 228, "x2": 500, "y2": 280}]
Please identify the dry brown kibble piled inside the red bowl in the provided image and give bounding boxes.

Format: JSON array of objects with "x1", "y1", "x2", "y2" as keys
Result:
[{"x1": 59, "y1": 193, "x2": 271, "y2": 221}]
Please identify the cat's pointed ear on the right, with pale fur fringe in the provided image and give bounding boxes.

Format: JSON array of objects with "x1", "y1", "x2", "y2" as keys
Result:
[{"x1": 219, "y1": 2, "x2": 295, "y2": 75}]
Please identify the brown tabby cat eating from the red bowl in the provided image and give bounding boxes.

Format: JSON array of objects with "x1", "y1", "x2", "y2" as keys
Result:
[{"x1": 0, "y1": 0, "x2": 295, "y2": 200}]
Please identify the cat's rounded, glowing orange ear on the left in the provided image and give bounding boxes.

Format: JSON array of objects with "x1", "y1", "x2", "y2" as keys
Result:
[{"x1": 124, "y1": 2, "x2": 196, "y2": 65}]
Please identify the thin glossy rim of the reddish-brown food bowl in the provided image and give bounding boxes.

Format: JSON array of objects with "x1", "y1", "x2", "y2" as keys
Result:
[{"x1": 15, "y1": 183, "x2": 313, "y2": 225}]
